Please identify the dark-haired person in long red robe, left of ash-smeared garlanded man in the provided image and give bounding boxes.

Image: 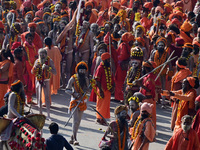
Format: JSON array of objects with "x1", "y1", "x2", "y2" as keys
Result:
[{"x1": 24, "y1": 33, "x2": 38, "y2": 104}]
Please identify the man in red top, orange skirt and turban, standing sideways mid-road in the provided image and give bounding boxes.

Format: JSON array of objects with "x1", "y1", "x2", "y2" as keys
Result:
[{"x1": 94, "y1": 52, "x2": 114, "y2": 124}]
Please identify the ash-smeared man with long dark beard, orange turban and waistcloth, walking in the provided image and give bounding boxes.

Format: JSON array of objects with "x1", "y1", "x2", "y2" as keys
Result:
[{"x1": 66, "y1": 61, "x2": 89, "y2": 145}]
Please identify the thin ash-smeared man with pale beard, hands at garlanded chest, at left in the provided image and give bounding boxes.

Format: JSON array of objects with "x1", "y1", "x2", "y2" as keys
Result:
[{"x1": 31, "y1": 48, "x2": 56, "y2": 121}]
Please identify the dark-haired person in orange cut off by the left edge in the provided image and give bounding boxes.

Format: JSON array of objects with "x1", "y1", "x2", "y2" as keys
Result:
[{"x1": 0, "y1": 49, "x2": 14, "y2": 108}]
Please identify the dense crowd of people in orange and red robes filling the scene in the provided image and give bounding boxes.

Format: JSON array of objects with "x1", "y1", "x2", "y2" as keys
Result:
[{"x1": 0, "y1": 0, "x2": 200, "y2": 150}]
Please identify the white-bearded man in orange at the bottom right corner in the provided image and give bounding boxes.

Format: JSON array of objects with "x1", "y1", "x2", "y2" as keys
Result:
[{"x1": 165, "y1": 115, "x2": 200, "y2": 150}]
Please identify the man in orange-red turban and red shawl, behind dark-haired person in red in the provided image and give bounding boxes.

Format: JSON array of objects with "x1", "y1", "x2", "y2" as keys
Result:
[{"x1": 21, "y1": 22, "x2": 43, "y2": 49}]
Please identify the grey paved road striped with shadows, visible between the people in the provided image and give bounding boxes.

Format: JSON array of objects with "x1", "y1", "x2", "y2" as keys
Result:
[{"x1": 28, "y1": 90, "x2": 172, "y2": 150}]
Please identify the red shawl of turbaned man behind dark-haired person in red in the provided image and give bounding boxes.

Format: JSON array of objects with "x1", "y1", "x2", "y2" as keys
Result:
[{"x1": 21, "y1": 31, "x2": 43, "y2": 49}]
